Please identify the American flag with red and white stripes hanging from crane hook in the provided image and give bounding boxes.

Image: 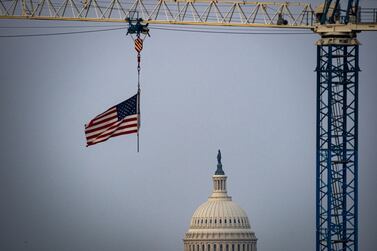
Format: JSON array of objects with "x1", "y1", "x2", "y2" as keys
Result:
[{"x1": 85, "y1": 94, "x2": 139, "y2": 146}]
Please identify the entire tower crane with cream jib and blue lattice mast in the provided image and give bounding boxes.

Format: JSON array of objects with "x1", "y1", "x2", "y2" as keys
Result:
[{"x1": 0, "y1": 0, "x2": 377, "y2": 251}]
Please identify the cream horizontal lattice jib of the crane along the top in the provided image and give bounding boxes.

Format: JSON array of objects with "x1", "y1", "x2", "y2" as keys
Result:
[{"x1": 0, "y1": 0, "x2": 315, "y2": 29}]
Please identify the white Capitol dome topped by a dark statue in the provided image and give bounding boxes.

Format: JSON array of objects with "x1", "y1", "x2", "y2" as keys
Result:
[{"x1": 183, "y1": 151, "x2": 257, "y2": 251}]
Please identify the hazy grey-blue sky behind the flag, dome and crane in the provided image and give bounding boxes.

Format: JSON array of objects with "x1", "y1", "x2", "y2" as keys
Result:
[{"x1": 0, "y1": 1, "x2": 377, "y2": 251}]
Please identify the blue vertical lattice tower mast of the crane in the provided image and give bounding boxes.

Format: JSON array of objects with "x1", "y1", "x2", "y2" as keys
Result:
[{"x1": 316, "y1": 45, "x2": 359, "y2": 251}]
